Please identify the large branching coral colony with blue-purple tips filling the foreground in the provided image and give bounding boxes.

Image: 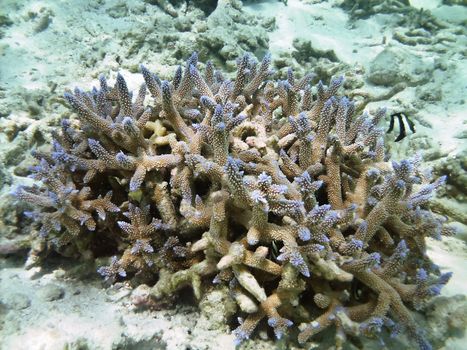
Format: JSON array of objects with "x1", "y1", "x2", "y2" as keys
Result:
[{"x1": 17, "y1": 54, "x2": 452, "y2": 349}]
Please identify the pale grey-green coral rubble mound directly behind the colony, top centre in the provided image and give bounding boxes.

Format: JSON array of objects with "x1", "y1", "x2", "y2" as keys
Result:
[{"x1": 143, "y1": 0, "x2": 275, "y2": 67}]
